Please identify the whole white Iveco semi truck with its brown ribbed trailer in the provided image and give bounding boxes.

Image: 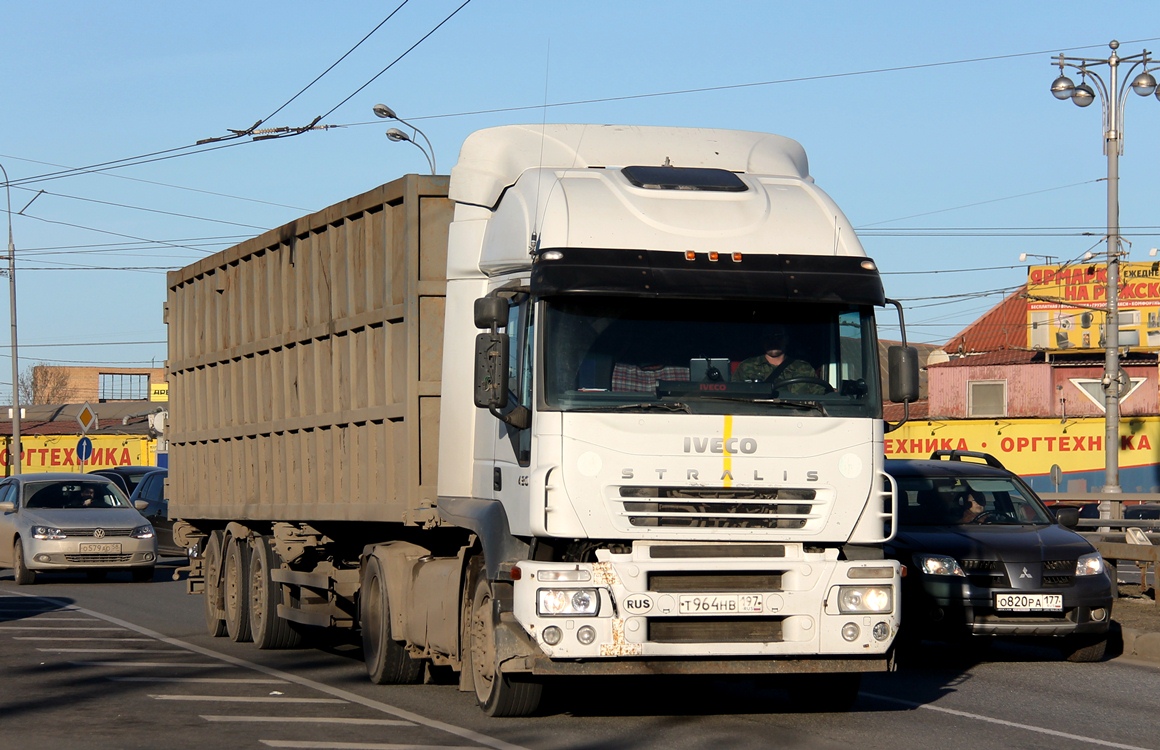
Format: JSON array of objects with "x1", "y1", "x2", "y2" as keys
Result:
[{"x1": 166, "y1": 125, "x2": 918, "y2": 715}]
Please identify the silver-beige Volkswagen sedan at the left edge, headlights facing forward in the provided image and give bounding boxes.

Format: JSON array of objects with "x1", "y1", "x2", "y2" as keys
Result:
[{"x1": 0, "y1": 473, "x2": 157, "y2": 585}]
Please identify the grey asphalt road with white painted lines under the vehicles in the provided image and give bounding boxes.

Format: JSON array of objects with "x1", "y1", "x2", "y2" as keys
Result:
[{"x1": 0, "y1": 568, "x2": 1160, "y2": 750}]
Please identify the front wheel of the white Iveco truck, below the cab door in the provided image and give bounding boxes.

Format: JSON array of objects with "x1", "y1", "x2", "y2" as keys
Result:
[{"x1": 471, "y1": 570, "x2": 544, "y2": 716}]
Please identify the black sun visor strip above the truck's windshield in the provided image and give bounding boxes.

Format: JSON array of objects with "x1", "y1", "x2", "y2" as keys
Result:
[{"x1": 531, "y1": 248, "x2": 886, "y2": 305}]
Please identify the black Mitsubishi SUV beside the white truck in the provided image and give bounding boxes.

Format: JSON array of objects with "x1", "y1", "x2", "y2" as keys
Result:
[{"x1": 885, "y1": 451, "x2": 1115, "y2": 662}]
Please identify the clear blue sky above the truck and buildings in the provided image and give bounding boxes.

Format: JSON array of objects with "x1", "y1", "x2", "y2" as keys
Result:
[{"x1": 0, "y1": 0, "x2": 1160, "y2": 399}]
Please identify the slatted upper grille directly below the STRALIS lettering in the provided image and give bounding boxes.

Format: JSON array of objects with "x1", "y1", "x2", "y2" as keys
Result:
[{"x1": 619, "y1": 487, "x2": 820, "y2": 529}]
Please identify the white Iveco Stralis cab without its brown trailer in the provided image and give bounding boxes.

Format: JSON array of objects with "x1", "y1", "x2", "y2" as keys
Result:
[{"x1": 438, "y1": 125, "x2": 916, "y2": 700}]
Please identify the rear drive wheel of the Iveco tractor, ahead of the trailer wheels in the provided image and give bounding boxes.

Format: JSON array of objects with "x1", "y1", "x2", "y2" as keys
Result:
[{"x1": 358, "y1": 556, "x2": 423, "y2": 685}]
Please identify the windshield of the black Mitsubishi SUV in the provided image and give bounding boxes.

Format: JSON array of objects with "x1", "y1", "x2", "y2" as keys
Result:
[{"x1": 897, "y1": 476, "x2": 1053, "y2": 526}]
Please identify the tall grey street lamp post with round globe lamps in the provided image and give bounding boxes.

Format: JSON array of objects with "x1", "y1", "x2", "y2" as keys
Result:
[{"x1": 1051, "y1": 39, "x2": 1160, "y2": 493}]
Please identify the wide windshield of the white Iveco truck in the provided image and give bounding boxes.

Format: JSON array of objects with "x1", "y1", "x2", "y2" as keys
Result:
[{"x1": 541, "y1": 296, "x2": 882, "y2": 417}]
